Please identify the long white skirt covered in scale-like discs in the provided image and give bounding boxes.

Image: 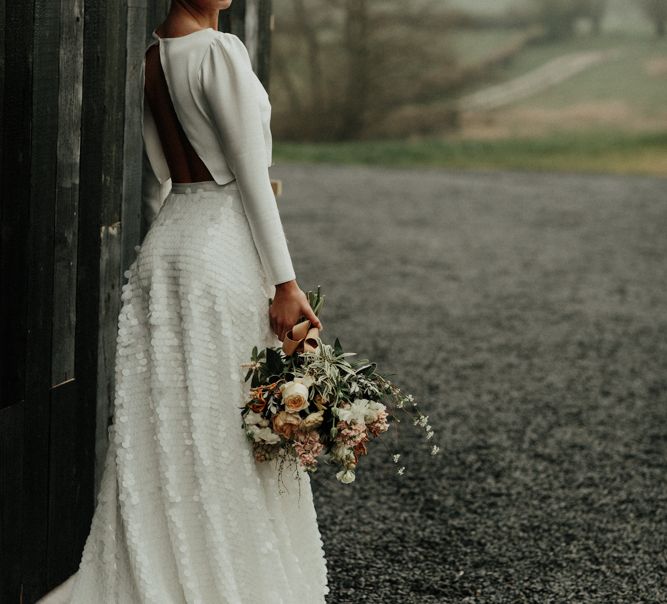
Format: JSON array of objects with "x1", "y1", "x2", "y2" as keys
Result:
[{"x1": 39, "y1": 181, "x2": 329, "y2": 604}]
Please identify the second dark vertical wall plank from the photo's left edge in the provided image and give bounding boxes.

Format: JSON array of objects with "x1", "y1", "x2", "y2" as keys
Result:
[{"x1": 22, "y1": 0, "x2": 60, "y2": 602}]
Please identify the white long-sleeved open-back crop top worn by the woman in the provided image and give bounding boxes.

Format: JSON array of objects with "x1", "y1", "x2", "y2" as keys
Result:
[{"x1": 141, "y1": 27, "x2": 295, "y2": 284}]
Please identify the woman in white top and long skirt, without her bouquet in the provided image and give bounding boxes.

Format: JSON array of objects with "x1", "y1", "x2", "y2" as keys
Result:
[{"x1": 40, "y1": 0, "x2": 329, "y2": 604}]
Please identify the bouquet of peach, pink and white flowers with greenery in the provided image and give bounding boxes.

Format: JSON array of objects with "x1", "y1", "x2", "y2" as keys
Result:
[{"x1": 241, "y1": 286, "x2": 439, "y2": 483}]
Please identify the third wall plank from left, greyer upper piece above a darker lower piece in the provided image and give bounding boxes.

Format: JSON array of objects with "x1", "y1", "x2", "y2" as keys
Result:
[{"x1": 46, "y1": 0, "x2": 84, "y2": 591}]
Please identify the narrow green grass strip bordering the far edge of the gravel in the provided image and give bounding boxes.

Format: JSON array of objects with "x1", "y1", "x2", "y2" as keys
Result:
[{"x1": 274, "y1": 129, "x2": 667, "y2": 176}]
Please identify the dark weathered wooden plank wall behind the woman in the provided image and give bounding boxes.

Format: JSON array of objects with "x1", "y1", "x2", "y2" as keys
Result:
[{"x1": 0, "y1": 0, "x2": 271, "y2": 604}]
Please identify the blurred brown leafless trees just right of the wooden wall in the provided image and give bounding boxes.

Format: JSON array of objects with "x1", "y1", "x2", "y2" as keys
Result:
[{"x1": 272, "y1": 0, "x2": 462, "y2": 140}]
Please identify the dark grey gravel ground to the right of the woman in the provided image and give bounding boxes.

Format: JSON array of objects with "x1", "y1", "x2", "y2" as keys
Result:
[{"x1": 271, "y1": 164, "x2": 667, "y2": 604}]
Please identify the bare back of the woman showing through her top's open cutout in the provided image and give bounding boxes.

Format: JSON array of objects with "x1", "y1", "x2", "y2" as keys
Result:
[{"x1": 144, "y1": 43, "x2": 214, "y2": 183}]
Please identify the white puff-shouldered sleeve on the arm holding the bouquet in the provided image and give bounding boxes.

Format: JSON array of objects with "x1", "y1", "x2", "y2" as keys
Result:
[{"x1": 199, "y1": 34, "x2": 295, "y2": 285}]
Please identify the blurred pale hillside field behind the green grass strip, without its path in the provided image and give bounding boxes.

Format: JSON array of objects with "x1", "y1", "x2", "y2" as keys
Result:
[{"x1": 452, "y1": 13, "x2": 667, "y2": 141}]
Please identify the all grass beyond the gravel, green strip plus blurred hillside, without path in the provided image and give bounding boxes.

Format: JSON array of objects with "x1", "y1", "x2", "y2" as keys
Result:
[{"x1": 274, "y1": 0, "x2": 667, "y2": 176}]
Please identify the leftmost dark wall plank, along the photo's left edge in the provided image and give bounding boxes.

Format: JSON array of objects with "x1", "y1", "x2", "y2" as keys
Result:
[{"x1": 0, "y1": 2, "x2": 33, "y2": 602}]
